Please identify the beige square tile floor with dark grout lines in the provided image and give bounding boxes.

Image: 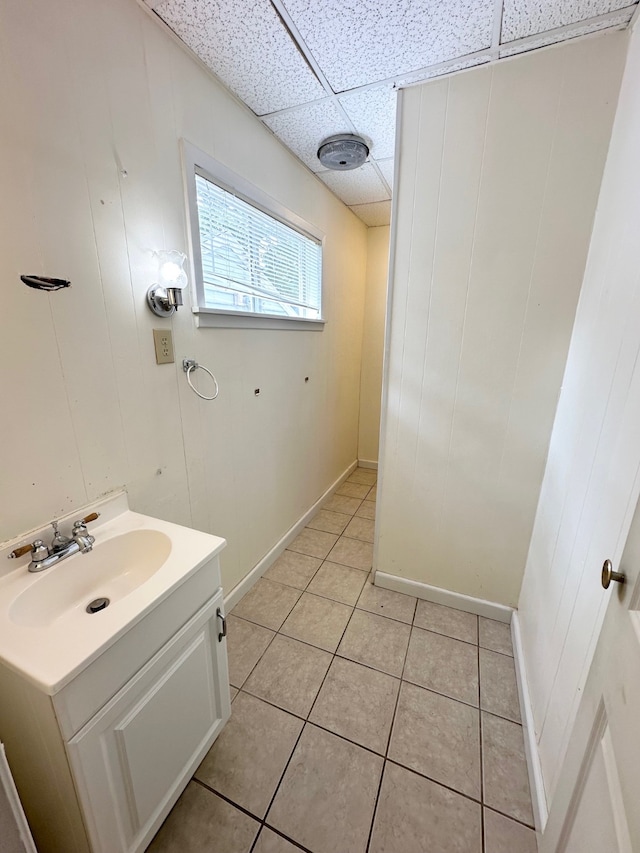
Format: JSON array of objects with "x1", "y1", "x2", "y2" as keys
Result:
[{"x1": 150, "y1": 469, "x2": 536, "y2": 853}]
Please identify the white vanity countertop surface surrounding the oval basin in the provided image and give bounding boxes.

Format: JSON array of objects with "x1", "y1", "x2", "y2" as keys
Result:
[{"x1": 0, "y1": 494, "x2": 226, "y2": 695}]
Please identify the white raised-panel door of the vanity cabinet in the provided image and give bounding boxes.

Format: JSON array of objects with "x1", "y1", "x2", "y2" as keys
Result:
[{"x1": 67, "y1": 590, "x2": 230, "y2": 853}]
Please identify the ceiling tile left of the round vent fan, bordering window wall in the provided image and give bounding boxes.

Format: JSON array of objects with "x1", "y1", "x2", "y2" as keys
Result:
[{"x1": 264, "y1": 100, "x2": 353, "y2": 172}]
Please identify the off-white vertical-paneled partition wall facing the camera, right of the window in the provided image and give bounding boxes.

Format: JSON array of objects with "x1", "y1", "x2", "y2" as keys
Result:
[{"x1": 376, "y1": 33, "x2": 626, "y2": 606}]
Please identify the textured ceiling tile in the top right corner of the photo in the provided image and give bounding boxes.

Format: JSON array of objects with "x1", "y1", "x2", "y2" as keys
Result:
[{"x1": 501, "y1": 0, "x2": 632, "y2": 43}]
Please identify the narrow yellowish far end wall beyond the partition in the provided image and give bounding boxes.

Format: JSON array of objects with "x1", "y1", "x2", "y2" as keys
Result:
[{"x1": 358, "y1": 225, "x2": 389, "y2": 463}]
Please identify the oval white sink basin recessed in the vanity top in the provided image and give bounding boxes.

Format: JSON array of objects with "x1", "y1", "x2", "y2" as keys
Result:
[{"x1": 9, "y1": 530, "x2": 171, "y2": 628}]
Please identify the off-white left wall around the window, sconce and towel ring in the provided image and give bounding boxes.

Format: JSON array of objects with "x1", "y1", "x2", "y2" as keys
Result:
[{"x1": 0, "y1": 0, "x2": 366, "y2": 589}]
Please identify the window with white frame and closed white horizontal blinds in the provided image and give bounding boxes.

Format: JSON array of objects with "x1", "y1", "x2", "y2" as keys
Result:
[{"x1": 184, "y1": 143, "x2": 322, "y2": 328}]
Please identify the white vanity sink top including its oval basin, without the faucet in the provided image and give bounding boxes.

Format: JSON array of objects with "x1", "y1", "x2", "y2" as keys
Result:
[{"x1": 0, "y1": 493, "x2": 226, "y2": 694}]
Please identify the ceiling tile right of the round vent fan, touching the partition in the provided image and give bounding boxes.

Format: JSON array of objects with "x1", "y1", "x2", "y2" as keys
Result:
[{"x1": 339, "y1": 86, "x2": 398, "y2": 160}]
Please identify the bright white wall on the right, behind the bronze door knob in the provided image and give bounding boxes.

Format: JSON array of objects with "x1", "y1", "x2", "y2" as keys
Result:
[{"x1": 520, "y1": 23, "x2": 640, "y2": 801}]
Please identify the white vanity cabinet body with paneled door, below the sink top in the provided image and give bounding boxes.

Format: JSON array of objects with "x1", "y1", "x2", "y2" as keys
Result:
[{"x1": 0, "y1": 556, "x2": 230, "y2": 853}]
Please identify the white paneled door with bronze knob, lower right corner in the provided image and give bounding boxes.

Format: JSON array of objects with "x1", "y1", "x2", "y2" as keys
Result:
[{"x1": 540, "y1": 502, "x2": 640, "y2": 853}]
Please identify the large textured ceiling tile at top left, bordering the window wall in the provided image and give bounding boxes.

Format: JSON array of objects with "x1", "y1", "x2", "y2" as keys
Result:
[{"x1": 155, "y1": 0, "x2": 325, "y2": 115}]
